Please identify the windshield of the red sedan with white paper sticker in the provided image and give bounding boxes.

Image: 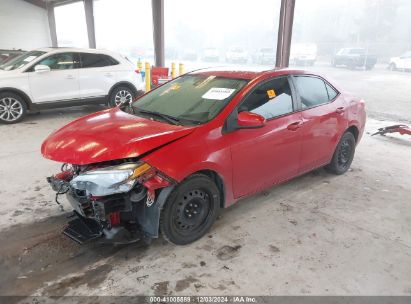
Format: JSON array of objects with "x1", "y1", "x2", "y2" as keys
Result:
[{"x1": 132, "y1": 75, "x2": 248, "y2": 124}]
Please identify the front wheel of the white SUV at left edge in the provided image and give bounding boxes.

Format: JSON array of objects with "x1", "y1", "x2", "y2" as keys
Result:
[{"x1": 0, "y1": 92, "x2": 27, "y2": 124}]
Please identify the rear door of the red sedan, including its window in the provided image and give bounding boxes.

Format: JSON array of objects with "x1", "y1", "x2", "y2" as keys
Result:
[{"x1": 293, "y1": 75, "x2": 346, "y2": 172}]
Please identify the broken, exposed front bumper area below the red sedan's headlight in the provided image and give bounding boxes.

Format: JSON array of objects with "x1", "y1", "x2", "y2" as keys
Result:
[{"x1": 47, "y1": 176, "x2": 174, "y2": 244}]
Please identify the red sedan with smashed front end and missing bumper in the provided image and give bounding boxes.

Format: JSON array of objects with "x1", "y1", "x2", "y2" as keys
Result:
[{"x1": 42, "y1": 69, "x2": 366, "y2": 244}]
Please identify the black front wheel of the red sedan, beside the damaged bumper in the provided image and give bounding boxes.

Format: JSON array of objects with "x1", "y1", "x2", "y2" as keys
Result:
[{"x1": 160, "y1": 174, "x2": 221, "y2": 245}]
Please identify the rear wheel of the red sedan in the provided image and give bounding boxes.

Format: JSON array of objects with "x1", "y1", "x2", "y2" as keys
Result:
[{"x1": 325, "y1": 131, "x2": 355, "y2": 175}]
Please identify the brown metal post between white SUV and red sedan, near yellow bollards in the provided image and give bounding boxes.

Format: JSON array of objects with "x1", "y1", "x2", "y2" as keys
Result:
[{"x1": 151, "y1": 0, "x2": 165, "y2": 67}]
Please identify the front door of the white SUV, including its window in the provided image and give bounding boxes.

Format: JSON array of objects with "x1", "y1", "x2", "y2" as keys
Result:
[{"x1": 28, "y1": 53, "x2": 80, "y2": 103}]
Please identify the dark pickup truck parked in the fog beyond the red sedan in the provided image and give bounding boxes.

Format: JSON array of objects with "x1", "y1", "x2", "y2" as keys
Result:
[{"x1": 331, "y1": 48, "x2": 377, "y2": 70}]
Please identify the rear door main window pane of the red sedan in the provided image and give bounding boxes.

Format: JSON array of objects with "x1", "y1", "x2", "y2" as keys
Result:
[{"x1": 294, "y1": 76, "x2": 329, "y2": 109}]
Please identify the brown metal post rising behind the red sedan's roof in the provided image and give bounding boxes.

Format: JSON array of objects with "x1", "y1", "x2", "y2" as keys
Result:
[{"x1": 275, "y1": 0, "x2": 295, "y2": 68}]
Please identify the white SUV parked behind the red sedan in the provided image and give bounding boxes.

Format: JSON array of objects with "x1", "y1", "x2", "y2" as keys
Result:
[{"x1": 0, "y1": 48, "x2": 144, "y2": 124}]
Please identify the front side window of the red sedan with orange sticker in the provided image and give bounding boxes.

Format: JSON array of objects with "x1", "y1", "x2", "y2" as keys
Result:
[{"x1": 239, "y1": 77, "x2": 293, "y2": 119}]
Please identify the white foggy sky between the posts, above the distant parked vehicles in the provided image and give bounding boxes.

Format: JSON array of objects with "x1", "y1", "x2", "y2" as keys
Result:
[{"x1": 55, "y1": 0, "x2": 411, "y2": 65}]
